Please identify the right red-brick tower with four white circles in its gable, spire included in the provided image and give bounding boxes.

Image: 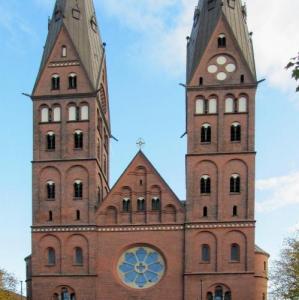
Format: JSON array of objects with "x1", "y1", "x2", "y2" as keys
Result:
[{"x1": 185, "y1": 0, "x2": 266, "y2": 300}]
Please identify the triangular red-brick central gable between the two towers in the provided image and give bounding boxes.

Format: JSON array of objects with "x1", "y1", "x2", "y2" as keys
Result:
[{"x1": 97, "y1": 151, "x2": 184, "y2": 225}]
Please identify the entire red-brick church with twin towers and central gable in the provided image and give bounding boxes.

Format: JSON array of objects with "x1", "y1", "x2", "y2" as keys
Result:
[{"x1": 26, "y1": 0, "x2": 269, "y2": 300}]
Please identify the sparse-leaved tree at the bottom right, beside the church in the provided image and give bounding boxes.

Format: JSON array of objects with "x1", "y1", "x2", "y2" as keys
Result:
[{"x1": 271, "y1": 232, "x2": 299, "y2": 300}]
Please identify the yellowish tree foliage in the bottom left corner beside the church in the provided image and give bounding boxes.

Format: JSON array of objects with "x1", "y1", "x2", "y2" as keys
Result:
[{"x1": 0, "y1": 269, "x2": 18, "y2": 300}]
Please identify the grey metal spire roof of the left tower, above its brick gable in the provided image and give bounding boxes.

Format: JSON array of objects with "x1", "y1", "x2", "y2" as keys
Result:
[{"x1": 37, "y1": 0, "x2": 104, "y2": 90}]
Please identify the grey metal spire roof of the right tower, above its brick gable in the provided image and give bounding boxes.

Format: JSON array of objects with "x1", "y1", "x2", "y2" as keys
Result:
[{"x1": 187, "y1": 0, "x2": 256, "y2": 82}]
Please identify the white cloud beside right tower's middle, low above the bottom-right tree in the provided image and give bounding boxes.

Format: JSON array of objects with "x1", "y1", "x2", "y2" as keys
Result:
[{"x1": 256, "y1": 172, "x2": 299, "y2": 212}]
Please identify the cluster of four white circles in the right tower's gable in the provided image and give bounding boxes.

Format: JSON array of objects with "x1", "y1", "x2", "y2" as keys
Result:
[{"x1": 208, "y1": 55, "x2": 237, "y2": 81}]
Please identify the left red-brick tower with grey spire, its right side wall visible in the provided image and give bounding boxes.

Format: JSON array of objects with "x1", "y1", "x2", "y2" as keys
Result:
[{"x1": 28, "y1": 0, "x2": 111, "y2": 299}]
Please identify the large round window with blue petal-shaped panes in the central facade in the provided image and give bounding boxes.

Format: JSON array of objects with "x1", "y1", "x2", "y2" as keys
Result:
[{"x1": 117, "y1": 247, "x2": 165, "y2": 289}]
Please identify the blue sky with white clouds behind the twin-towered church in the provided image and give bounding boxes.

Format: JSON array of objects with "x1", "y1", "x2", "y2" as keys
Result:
[{"x1": 0, "y1": 0, "x2": 299, "y2": 292}]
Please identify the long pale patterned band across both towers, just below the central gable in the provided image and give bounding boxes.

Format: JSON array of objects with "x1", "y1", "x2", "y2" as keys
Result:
[{"x1": 32, "y1": 222, "x2": 255, "y2": 233}]
